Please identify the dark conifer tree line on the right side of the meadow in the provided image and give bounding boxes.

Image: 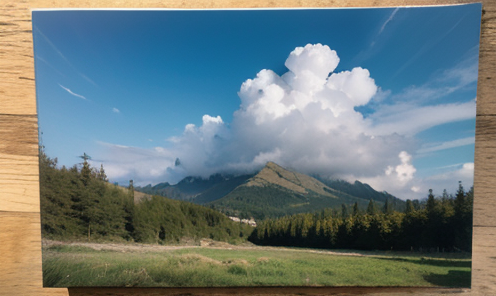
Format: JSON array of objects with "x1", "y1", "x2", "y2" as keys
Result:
[{"x1": 249, "y1": 182, "x2": 473, "y2": 251}]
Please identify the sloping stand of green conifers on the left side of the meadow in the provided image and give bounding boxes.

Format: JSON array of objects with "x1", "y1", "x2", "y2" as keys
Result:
[{"x1": 40, "y1": 149, "x2": 253, "y2": 243}]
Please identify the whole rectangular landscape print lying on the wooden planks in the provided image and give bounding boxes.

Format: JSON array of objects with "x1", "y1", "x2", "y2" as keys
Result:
[{"x1": 32, "y1": 4, "x2": 482, "y2": 287}]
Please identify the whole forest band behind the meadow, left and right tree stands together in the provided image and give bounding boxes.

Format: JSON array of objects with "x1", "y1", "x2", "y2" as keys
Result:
[{"x1": 40, "y1": 151, "x2": 473, "y2": 252}]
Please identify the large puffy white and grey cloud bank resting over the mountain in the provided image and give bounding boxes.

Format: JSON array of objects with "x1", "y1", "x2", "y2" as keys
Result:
[{"x1": 99, "y1": 44, "x2": 475, "y2": 199}]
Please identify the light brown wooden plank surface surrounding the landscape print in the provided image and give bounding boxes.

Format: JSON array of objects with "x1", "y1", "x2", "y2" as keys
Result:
[{"x1": 0, "y1": 0, "x2": 496, "y2": 296}]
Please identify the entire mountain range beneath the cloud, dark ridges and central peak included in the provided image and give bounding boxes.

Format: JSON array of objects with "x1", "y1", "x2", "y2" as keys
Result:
[{"x1": 137, "y1": 162, "x2": 404, "y2": 219}]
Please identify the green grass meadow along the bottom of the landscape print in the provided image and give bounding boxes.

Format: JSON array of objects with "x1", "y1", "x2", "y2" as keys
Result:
[{"x1": 43, "y1": 245, "x2": 471, "y2": 287}]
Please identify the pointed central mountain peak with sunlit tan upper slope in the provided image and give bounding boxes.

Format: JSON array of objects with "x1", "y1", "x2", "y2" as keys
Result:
[{"x1": 210, "y1": 162, "x2": 382, "y2": 219}]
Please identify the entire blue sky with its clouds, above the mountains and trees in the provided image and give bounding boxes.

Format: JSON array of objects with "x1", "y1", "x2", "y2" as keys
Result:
[{"x1": 32, "y1": 4, "x2": 481, "y2": 198}]
